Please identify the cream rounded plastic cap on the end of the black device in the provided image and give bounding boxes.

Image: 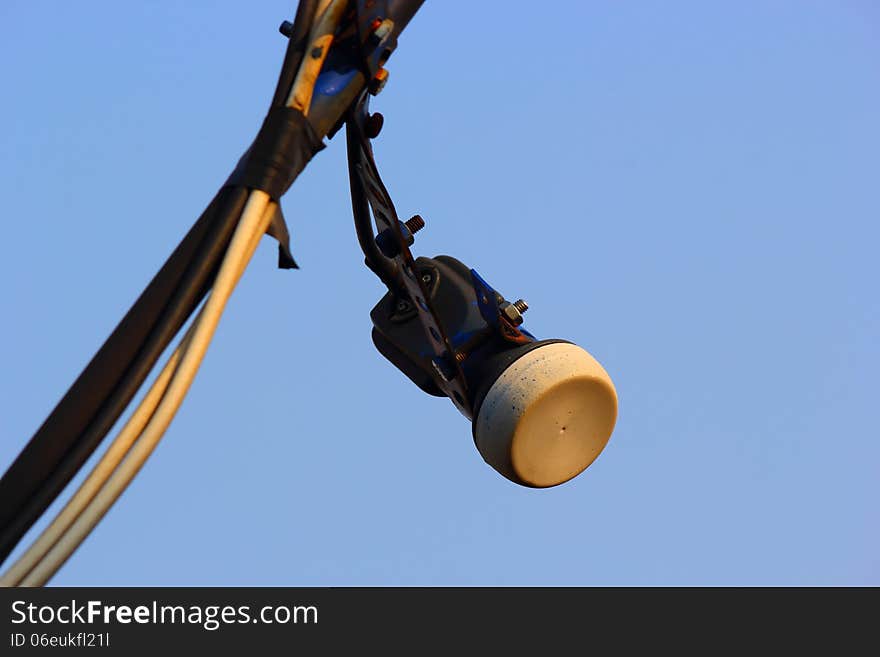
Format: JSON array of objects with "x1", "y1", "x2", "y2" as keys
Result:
[{"x1": 474, "y1": 342, "x2": 617, "y2": 488}]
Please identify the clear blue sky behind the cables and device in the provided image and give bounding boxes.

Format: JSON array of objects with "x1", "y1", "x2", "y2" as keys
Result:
[{"x1": 0, "y1": 0, "x2": 880, "y2": 585}]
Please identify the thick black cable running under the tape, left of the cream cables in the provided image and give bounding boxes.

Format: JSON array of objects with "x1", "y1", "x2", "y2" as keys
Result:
[{"x1": 0, "y1": 0, "x2": 317, "y2": 562}]
